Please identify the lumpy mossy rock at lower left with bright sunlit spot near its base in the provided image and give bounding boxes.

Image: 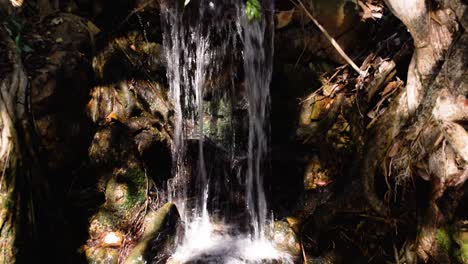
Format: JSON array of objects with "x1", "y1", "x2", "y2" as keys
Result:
[{"x1": 84, "y1": 124, "x2": 151, "y2": 263}]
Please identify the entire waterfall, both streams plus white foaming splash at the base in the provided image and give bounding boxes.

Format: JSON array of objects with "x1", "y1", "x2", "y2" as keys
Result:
[{"x1": 161, "y1": 0, "x2": 290, "y2": 263}]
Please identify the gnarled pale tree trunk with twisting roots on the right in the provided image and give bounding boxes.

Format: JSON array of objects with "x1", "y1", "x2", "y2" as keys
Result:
[{"x1": 361, "y1": 0, "x2": 468, "y2": 263}]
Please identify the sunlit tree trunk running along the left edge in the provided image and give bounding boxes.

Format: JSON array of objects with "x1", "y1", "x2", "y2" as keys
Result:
[{"x1": 0, "y1": 22, "x2": 27, "y2": 263}]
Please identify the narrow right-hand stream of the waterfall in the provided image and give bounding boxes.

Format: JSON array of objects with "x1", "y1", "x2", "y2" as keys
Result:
[{"x1": 239, "y1": 1, "x2": 274, "y2": 239}]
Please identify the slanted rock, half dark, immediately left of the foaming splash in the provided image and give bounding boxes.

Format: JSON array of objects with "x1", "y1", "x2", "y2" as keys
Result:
[{"x1": 124, "y1": 203, "x2": 180, "y2": 264}]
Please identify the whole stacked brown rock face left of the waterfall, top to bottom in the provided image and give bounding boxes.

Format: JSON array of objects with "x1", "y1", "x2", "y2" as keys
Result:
[{"x1": 84, "y1": 25, "x2": 173, "y2": 263}]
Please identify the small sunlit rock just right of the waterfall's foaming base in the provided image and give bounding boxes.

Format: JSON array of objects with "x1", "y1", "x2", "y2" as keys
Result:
[{"x1": 265, "y1": 221, "x2": 301, "y2": 258}]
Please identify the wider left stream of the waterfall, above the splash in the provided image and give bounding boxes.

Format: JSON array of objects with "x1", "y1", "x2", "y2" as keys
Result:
[{"x1": 161, "y1": 1, "x2": 235, "y2": 231}]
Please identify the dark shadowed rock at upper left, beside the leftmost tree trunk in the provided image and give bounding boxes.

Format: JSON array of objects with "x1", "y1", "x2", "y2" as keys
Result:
[{"x1": 25, "y1": 13, "x2": 94, "y2": 170}]
